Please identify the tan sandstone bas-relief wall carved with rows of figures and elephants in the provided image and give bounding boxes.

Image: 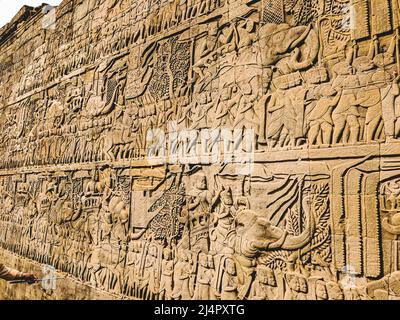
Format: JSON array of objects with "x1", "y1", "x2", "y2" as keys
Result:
[{"x1": 0, "y1": 0, "x2": 400, "y2": 300}]
